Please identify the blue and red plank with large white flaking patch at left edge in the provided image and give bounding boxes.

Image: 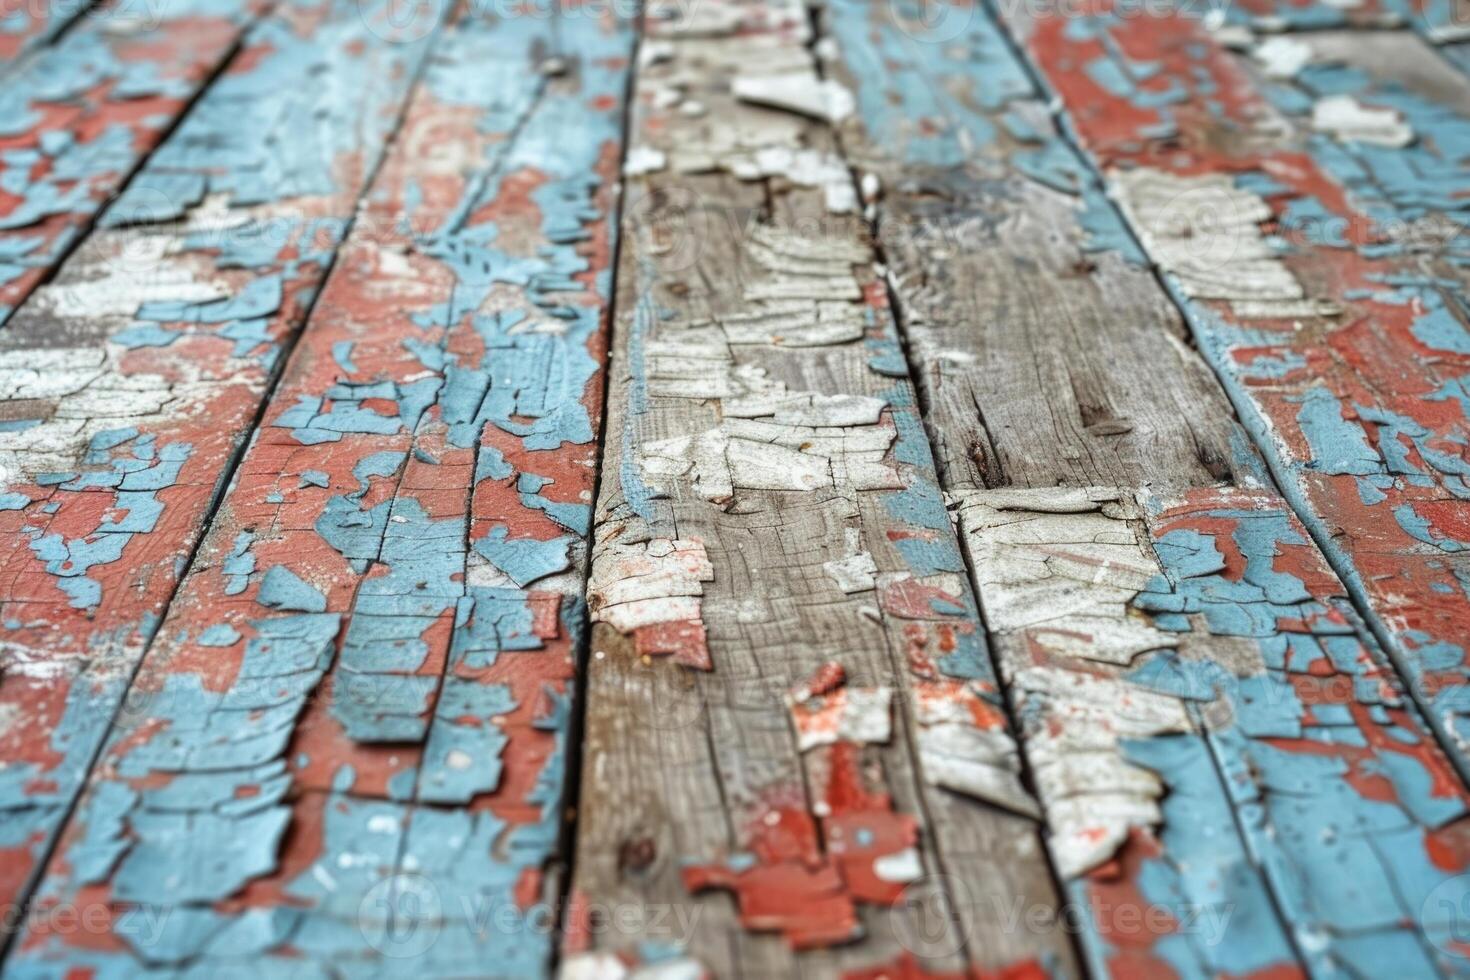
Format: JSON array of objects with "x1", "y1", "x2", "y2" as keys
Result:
[{"x1": 0, "y1": 0, "x2": 443, "y2": 940}]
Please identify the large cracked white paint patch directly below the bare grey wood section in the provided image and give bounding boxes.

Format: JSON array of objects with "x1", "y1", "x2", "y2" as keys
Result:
[{"x1": 960, "y1": 488, "x2": 1194, "y2": 877}]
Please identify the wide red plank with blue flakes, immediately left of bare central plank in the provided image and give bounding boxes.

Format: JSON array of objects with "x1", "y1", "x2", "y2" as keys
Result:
[{"x1": 10, "y1": 7, "x2": 632, "y2": 977}]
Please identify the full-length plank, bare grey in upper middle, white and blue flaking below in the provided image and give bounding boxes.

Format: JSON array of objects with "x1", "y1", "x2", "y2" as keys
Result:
[{"x1": 831, "y1": 0, "x2": 1470, "y2": 977}]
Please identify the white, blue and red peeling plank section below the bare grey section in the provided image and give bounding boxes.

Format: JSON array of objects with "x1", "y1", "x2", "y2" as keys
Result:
[{"x1": 960, "y1": 488, "x2": 1467, "y2": 973}]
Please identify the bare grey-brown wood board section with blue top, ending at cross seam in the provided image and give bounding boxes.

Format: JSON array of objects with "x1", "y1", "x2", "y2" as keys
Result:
[{"x1": 831, "y1": 0, "x2": 1244, "y2": 489}]
